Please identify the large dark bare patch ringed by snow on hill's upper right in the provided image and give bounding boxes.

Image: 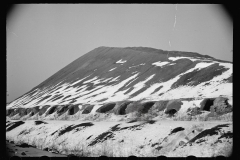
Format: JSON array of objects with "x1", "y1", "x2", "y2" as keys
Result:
[{"x1": 171, "y1": 64, "x2": 228, "y2": 88}]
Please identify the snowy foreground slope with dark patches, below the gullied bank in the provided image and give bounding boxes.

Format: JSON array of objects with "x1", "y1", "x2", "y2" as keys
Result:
[{"x1": 6, "y1": 120, "x2": 232, "y2": 157}]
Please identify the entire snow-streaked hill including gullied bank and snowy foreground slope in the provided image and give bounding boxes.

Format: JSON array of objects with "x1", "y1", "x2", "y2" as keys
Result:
[{"x1": 6, "y1": 47, "x2": 233, "y2": 157}]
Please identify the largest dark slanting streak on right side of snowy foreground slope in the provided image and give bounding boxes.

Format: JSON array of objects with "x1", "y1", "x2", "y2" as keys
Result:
[{"x1": 188, "y1": 124, "x2": 229, "y2": 143}]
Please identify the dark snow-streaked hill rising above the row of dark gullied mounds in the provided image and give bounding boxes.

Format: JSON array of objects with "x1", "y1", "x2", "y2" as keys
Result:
[{"x1": 7, "y1": 47, "x2": 232, "y2": 120}]
